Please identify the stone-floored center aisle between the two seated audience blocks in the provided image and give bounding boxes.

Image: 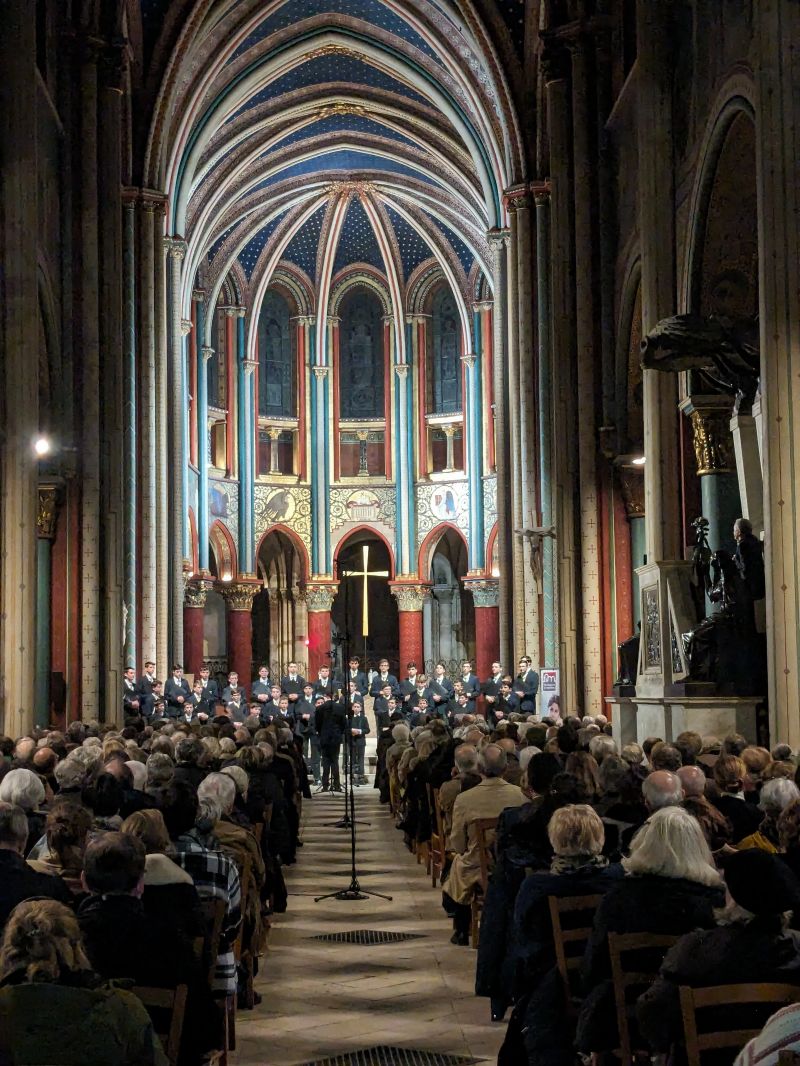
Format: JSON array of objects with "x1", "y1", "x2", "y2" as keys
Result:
[{"x1": 231, "y1": 786, "x2": 506, "y2": 1066}]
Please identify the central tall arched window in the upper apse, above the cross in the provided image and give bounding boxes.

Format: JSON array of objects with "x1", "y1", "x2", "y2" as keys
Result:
[{"x1": 339, "y1": 289, "x2": 384, "y2": 419}]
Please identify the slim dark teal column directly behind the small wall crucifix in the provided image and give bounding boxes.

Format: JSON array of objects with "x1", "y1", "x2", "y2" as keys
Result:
[{"x1": 535, "y1": 189, "x2": 559, "y2": 669}]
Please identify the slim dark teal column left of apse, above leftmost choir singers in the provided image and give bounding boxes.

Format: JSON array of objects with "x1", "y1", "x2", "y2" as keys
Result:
[{"x1": 123, "y1": 198, "x2": 136, "y2": 666}]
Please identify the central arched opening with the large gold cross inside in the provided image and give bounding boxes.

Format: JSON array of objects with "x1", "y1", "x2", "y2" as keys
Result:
[{"x1": 331, "y1": 530, "x2": 400, "y2": 676}]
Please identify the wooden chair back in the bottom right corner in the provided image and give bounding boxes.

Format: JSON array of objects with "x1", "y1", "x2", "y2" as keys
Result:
[{"x1": 681, "y1": 984, "x2": 800, "y2": 1066}]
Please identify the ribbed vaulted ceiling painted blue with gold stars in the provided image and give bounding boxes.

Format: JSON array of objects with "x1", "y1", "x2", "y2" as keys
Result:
[{"x1": 142, "y1": 0, "x2": 524, "y2": 336}]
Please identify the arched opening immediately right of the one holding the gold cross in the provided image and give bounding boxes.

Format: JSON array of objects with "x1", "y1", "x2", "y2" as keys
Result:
[{"x1": 422, "y1": 529, "x2": 475, "y2": 676}]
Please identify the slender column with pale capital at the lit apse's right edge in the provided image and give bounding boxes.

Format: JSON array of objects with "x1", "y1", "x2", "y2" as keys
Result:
[{"x1": 487, "y1": 229, "x2": 514, "y2": 662}]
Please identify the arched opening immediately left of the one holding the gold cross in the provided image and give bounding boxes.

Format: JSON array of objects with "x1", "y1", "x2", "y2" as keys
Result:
[{"x1": 253, "y1": 530, "x2": 305, "y2": 678}]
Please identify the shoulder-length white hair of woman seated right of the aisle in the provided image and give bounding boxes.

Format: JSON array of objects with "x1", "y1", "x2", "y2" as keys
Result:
[{"x1": 622, "y1": 807, "x2": 722, "y2": 886}]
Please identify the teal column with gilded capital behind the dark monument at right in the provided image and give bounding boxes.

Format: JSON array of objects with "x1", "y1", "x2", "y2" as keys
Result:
[{"x1": 681, "y1": 397, "x2": 741, "y2": 551}]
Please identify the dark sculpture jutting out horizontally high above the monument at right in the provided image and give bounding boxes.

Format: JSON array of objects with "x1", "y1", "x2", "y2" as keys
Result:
[{"x1": 642, "y1": 314, "x2": 761, "y2": 415}]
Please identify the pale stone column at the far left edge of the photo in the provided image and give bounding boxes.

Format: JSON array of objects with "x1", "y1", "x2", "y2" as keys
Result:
[{"x1": 0, "y1": 0, "x2": 42, "y2": 736}]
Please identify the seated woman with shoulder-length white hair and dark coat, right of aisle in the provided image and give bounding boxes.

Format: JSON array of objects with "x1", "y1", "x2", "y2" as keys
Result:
[{"x1": 577, "y1": 807, "x2": 724, "y2": 1054}]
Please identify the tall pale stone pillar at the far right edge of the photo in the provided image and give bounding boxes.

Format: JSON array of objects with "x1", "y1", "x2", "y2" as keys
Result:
[{"x1": 753, "y1": 0, "x2": 800, "y2": 746}]
